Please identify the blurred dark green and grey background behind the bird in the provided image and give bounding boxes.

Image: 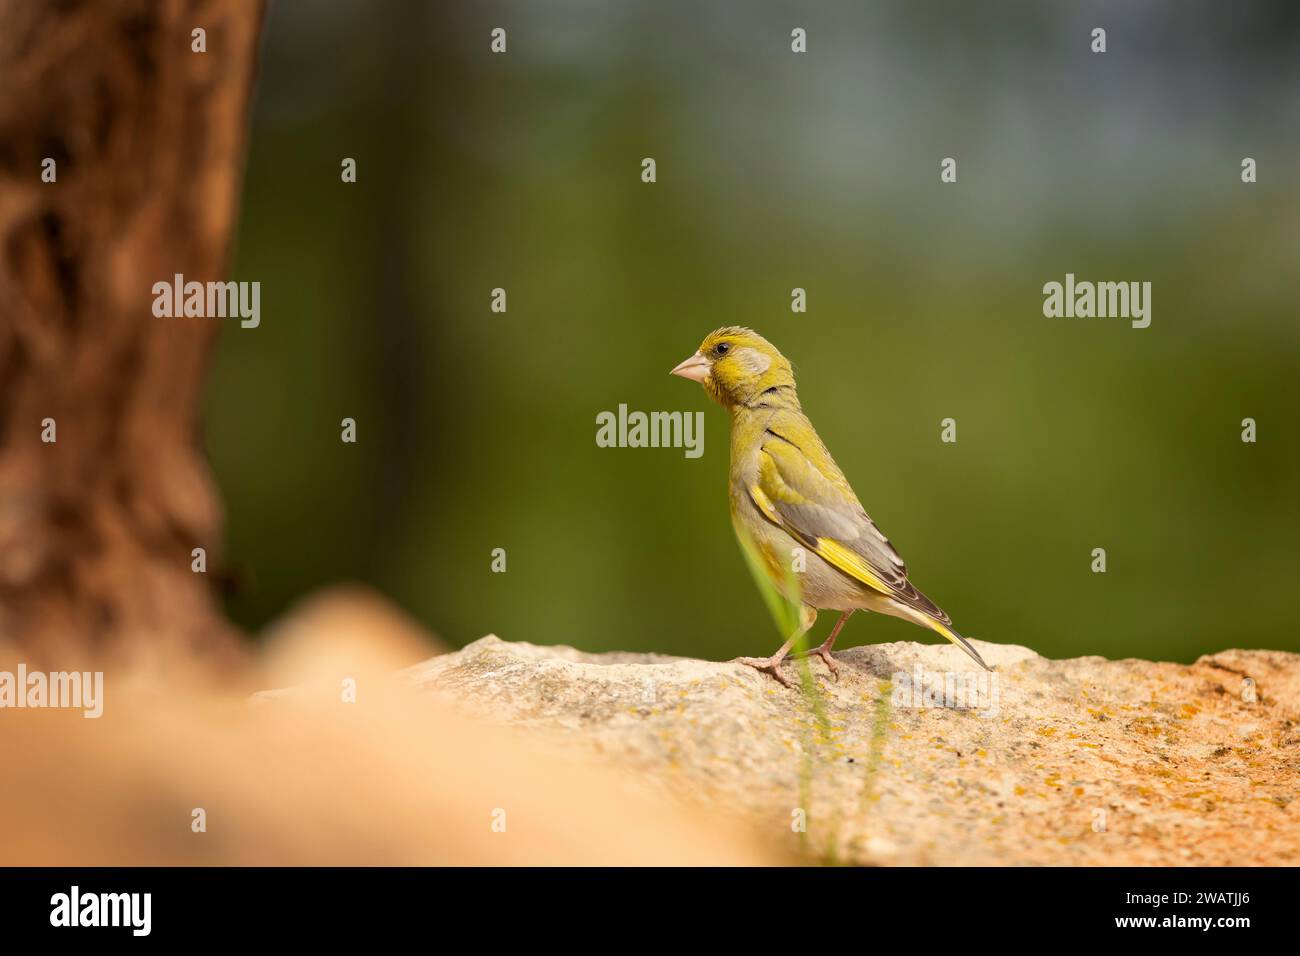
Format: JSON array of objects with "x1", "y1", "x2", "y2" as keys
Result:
[{"x1": 208, "y1": 0, "x2": 1300, "y2": 661}]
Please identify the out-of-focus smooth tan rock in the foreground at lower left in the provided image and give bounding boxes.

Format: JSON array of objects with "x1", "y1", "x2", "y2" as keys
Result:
[{"x1": 0, "y1": 592, "x2": 781, "y2": 865}]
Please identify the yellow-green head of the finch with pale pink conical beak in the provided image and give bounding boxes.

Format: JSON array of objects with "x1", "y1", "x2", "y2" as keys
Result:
[{"x1": 672, "y1": 325, "x2": 794, "y2": 408}]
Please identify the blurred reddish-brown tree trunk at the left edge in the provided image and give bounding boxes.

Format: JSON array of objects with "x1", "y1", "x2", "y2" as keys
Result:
[{"x1": 0, "y1": 0, "x2": 263, "y2": 669}]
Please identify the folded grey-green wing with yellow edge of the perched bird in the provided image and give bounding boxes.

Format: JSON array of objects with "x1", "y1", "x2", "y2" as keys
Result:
[{"x1": 749, "y1": 428, "x2": 952, "y2": 624}]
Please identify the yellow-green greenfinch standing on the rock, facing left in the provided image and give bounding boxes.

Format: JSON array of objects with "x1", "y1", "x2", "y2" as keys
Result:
[{"x1": 672, "y1": 326, "x2": 989, "y2": 687}]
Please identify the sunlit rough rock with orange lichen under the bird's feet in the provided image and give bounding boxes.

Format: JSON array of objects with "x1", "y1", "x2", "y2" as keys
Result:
[{"x1": 407, "y1": 636, "x2": 1300, "y2": 865}]
